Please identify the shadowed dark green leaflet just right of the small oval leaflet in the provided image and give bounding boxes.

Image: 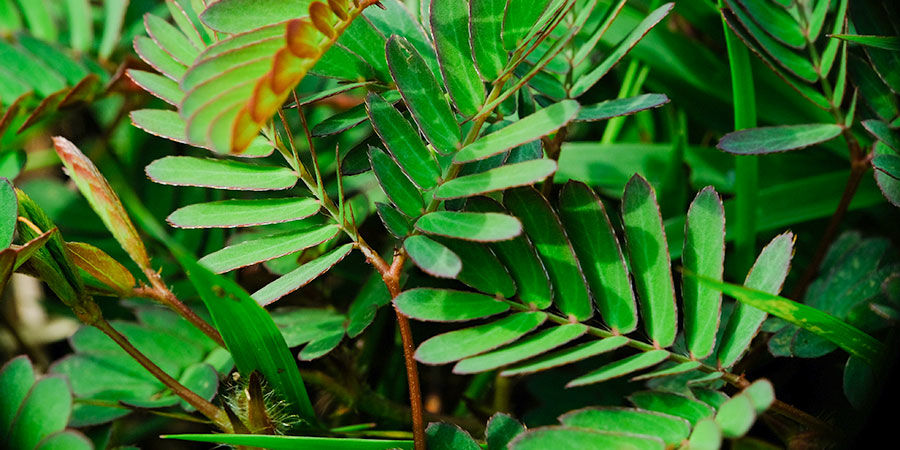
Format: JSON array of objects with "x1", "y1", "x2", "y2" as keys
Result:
[{"x1": 434, "y1": 237, "x2": 516, "y2": 298}]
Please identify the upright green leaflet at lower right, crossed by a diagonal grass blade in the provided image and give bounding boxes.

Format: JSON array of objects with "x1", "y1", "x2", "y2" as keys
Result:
[{"x1": 717, "y1": 232, "x2": 794, "y2": 367}]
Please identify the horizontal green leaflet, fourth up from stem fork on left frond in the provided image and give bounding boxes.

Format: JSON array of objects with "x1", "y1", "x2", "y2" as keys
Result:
[{"x1": 144, "y1": 156, "x2": 297, "y2": 191}]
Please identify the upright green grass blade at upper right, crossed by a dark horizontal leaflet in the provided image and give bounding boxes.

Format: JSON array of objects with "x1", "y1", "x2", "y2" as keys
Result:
[{"x1": 719, "y1": 0, "x2": 759, "y2": 273}]
